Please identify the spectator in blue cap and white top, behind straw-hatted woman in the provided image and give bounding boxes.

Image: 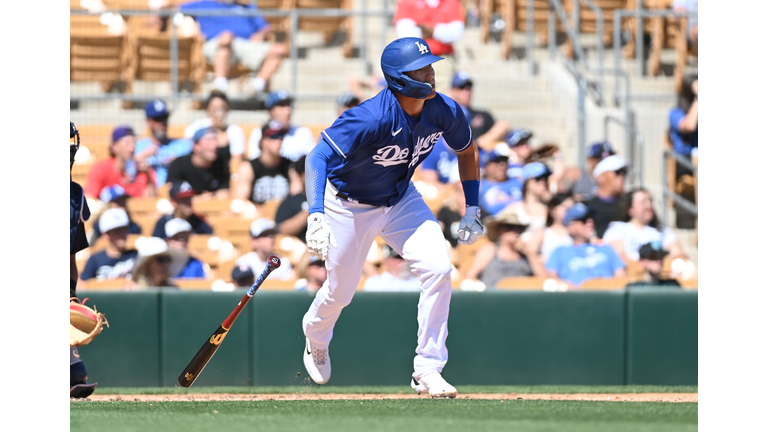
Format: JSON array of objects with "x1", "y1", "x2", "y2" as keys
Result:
[{"x1": 515, "y1": 162, "x2": 552, "y2": 243}]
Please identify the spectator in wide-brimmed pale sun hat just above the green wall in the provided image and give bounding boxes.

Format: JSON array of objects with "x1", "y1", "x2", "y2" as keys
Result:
[{"x1": 131, "y1": 237, "x2": 189, "y2": 290}]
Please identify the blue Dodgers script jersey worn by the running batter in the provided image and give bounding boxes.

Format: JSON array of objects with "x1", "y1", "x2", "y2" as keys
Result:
[{"x1": 320, "y1": 89, "x2": 472, "y2": 206}]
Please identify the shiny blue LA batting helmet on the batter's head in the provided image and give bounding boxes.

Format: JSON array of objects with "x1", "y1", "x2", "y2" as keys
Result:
[{"x1": 381, "y1": 37, "x2": 443, "y2": 99}]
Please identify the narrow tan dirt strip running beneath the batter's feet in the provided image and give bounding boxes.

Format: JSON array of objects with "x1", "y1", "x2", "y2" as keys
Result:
[{"x1": 81, "y1": 393, "x2": 699, "y2": 403}]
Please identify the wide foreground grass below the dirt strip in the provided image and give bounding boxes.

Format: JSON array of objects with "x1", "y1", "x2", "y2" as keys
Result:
[{"x1": 70, "y1": 399, "x2": 698, "y2": 432}]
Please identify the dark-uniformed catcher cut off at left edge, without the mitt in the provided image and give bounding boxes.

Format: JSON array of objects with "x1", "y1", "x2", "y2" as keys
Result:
[{"x1": 69, "y1": 122, "x2": 98, "y2": 398}]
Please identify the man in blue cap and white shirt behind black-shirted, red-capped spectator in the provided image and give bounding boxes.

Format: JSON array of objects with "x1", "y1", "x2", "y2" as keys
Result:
[{"x1": 248, "y1": 90, "x2": 316, "y2": 161}]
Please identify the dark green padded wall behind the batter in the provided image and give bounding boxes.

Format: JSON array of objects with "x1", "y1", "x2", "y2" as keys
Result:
[{"x1": 79, "y1": 289, "x2": 698, "y2": 387}]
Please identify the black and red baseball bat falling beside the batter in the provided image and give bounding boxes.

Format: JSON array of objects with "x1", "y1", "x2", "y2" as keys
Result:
[{"x1": 177, "y1": 255, "x2": 280, "y2": 387}]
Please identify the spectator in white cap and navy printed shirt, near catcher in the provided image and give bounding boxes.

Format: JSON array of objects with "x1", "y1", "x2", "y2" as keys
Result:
[{"x1": 80, "y1": 208, "x2": 137, "y2": 283}]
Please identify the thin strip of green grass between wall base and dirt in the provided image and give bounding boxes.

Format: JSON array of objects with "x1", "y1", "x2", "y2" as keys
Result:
[{"x1": 96, "y1": 385, "x2": 699, "y2": 395}]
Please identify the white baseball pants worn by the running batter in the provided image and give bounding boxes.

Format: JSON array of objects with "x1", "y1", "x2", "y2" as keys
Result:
[{"x1": 302, "y1": 182, "x2": 451, "y2": 380}]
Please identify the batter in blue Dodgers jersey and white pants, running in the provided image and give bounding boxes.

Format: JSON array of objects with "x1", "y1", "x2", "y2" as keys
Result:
[{"x1": 302, "y1": 37, "x2": 483, "y2": 398}]
